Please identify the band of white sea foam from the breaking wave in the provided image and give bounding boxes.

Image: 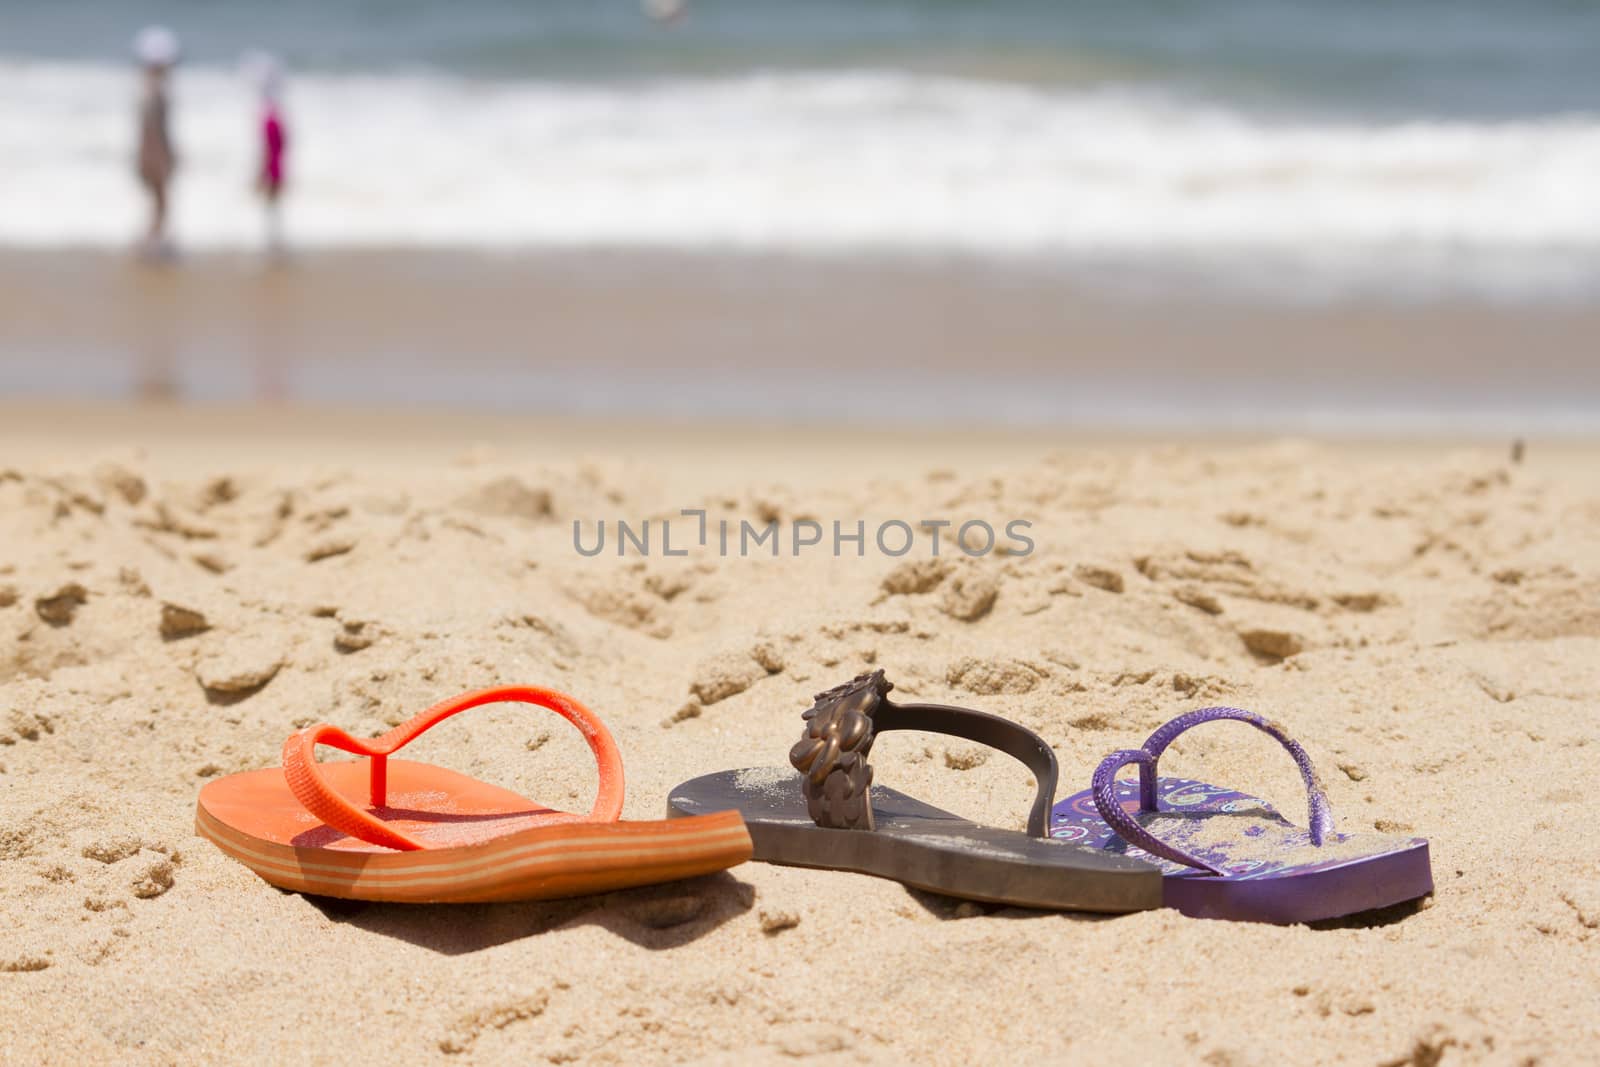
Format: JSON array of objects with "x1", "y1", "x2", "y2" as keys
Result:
[{"x1": 0, "y1": 61, "x2": 1600, "y2": 294}]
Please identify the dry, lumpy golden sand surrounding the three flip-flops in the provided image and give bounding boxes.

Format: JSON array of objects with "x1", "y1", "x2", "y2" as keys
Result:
[{"x1": 0, "y1": 421, "x2": 1600, "y2": 1064}]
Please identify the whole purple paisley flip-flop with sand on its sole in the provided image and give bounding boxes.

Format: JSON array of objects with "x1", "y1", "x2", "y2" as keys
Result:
[{"x1": 1050, "y1": 707, "x2": 1434, "y2": 923}]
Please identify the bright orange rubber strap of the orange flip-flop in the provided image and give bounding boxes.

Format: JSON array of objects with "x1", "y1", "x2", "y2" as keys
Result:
[{"x1": 283, "y1": 685, "x2": 622, "y2": 851}]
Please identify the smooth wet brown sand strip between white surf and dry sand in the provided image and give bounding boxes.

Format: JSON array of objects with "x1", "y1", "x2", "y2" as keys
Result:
[{"x1": 0, "y1": 250, "x2": 1600, "y2": 438}]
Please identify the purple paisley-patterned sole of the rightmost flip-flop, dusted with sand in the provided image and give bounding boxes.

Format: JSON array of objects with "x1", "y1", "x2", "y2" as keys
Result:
[{"x1": 1050, "y1": 777, "x2": 1434, "y2": 923}]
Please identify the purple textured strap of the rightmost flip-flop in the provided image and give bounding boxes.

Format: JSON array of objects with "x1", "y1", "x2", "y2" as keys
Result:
[{"x1": 1091, "y1": 707, "x2": 1333, "y2": 875}]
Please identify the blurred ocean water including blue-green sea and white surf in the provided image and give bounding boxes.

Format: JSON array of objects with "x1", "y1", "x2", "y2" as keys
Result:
[{"x1": 0, "y1": 0, "x2": 1600, "y2": 299}]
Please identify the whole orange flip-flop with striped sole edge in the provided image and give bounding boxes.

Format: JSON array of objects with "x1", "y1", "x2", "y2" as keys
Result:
[{"x1": 195, "y1": 686, "x2": 750, "y2": 904}]
